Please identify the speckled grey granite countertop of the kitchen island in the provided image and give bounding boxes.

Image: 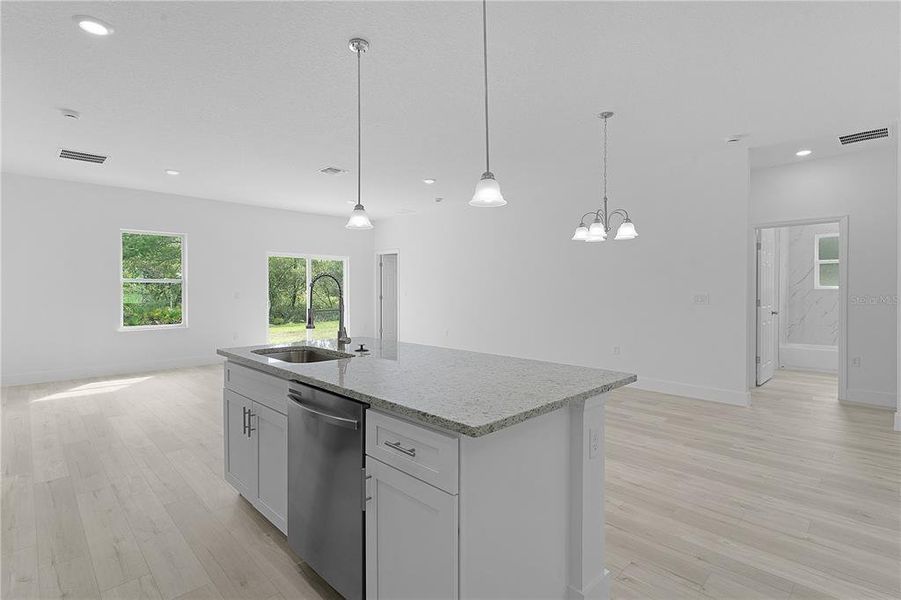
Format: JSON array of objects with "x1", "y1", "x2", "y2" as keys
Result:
[{"x1": 218, "y1": 337, "x2": 637, "y2": 437}]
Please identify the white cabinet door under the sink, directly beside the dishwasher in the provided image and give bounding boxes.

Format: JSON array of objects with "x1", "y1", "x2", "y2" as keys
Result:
[{"x1": 251, "y1": 402, "x2": 288, "y2": 533}]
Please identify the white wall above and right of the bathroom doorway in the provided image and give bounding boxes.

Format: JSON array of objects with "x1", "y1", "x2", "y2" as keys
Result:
[{"x1": 750, "y1": 148, "x2": 898, "y2": 406}]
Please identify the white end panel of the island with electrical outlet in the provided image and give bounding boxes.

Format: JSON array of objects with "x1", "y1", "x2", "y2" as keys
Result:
[{"x1": 460, "y1": 396, "x2": 608, "y2": 599}]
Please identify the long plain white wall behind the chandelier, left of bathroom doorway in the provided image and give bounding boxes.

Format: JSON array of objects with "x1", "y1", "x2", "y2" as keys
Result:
[{"x1": 376, "y1": 149, "x2": 748, "y2": 404}]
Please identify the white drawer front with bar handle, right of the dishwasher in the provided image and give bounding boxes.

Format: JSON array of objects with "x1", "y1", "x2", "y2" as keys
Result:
[{"x1": 366, "y1": 410, "x2": 459, "y2": 494}]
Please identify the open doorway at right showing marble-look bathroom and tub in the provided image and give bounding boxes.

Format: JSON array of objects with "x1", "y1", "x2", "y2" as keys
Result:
[{"x1": 753, "y1": 217, "x2": 848, "y2": 400}]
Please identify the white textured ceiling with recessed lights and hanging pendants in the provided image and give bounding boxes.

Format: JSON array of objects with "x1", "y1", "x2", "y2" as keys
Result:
[{"x1": 2, "y1": 1, "x2": 899, "y2": 218}]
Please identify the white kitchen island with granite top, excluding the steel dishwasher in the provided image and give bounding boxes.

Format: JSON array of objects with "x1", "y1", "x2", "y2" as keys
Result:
[{"x1": 219, "y1": 338, "x2": 636, "y2": 599}]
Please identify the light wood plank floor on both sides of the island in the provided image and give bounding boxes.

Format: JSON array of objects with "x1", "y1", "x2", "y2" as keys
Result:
[{"x1": 0, "y1": 367, "x2": 901, "y2": 600}]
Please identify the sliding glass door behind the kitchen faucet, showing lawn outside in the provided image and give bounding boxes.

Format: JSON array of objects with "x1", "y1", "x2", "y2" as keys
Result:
[{"x1": 269, "y1": 255, "x2": 348, "y2": 344}]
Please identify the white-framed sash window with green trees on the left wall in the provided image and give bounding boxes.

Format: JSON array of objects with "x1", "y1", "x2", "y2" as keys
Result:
[{"x1": 120, "y1": 231, "x2": 185, "y2": 329}]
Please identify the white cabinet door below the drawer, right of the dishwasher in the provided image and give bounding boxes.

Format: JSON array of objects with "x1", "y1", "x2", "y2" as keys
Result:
[{"x1": 366, "y1": 457, "x2": 457, "y2": 600}]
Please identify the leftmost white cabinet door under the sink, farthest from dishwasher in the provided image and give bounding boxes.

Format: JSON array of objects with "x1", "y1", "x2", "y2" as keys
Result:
[{"x1": 223, "y1": 390, "x2": 257, "y2": 502}]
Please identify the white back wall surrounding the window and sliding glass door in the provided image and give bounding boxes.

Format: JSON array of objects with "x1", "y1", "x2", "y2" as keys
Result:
[{"x1": 2, "y1": 173, "x2": 374, "y2": 385}]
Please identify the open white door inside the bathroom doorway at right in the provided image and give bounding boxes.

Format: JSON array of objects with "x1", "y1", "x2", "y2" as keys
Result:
[{"x1": 756, "y1": 229, "x2": 778, "y2": 385}]
